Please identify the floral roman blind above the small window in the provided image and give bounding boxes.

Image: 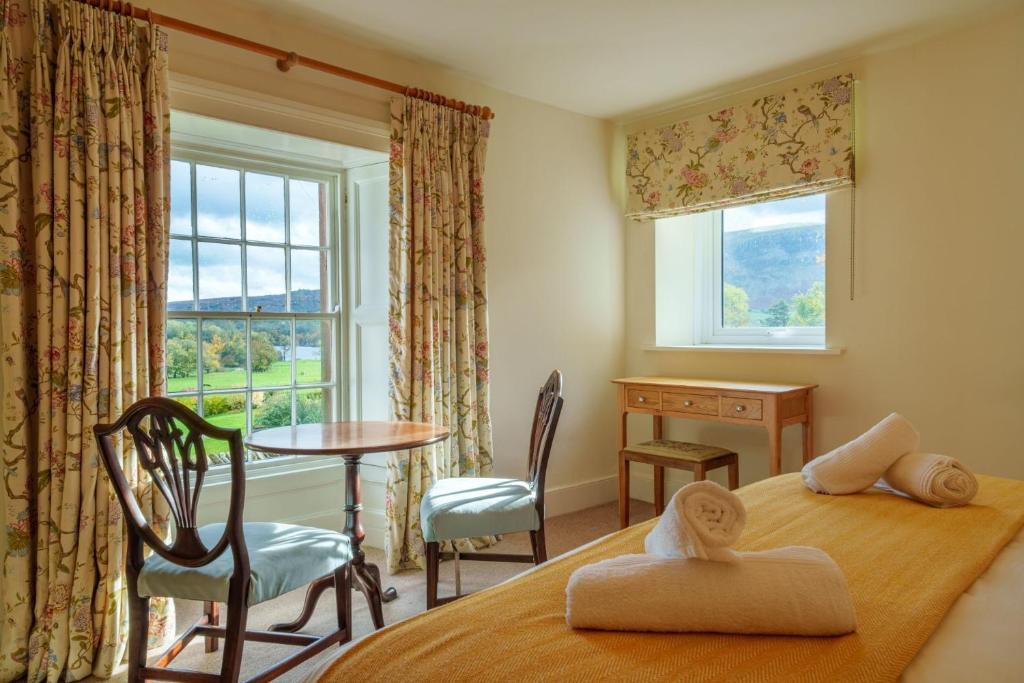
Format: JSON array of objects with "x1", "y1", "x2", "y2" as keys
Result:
[{"x1": 626, "y1": 74, "x2": 854, "y2": 220}]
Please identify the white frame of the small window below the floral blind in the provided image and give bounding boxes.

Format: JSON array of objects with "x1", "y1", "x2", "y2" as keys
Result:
[{"x1": 694, "y1": 195, "x2": 828, "y2": 347}]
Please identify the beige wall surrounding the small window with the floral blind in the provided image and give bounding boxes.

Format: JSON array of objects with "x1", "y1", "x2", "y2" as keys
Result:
[{"x1": 616, "y1": 3, "x2": 1024, "y2": 491}]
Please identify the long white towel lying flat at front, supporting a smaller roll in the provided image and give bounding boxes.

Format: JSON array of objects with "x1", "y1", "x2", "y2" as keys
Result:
[{"x1": 565, "y1": 547, "x2": 857, "y2": 636}]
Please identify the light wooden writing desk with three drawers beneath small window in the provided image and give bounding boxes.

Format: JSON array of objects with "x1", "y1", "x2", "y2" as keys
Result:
[{"x1": 612, "y1": 377, "x2": 817, "y2": 528}]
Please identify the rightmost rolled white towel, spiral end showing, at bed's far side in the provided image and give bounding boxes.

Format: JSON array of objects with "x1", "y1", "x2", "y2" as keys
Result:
[{"x1": 882, "y1": 453, "x2": 978, "y2": 508}]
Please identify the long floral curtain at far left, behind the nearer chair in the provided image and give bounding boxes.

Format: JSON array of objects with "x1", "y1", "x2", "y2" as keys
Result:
[{"x1": 0, "y1": 0, "x2": 174, "y2": 681}]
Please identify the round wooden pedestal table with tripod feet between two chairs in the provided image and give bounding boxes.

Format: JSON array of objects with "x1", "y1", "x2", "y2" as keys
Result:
[{"x1": 245, "y1": 422, "x2": 449, "y2": 632}]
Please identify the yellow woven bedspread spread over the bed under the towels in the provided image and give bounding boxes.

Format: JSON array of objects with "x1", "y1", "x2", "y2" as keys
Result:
[{"x1": 321, "y1": 474, "x2": 1024, "y2": 682}]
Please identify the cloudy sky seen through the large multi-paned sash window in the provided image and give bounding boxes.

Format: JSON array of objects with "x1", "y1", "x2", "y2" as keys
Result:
[{"x1": 168, "y1": 161, "x2": 319, "y2": 309}]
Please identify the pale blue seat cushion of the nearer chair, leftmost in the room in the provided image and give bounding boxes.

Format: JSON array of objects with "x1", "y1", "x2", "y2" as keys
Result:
[{"x1": 138, "y1": 522, "x2": 352, "y2": 605}]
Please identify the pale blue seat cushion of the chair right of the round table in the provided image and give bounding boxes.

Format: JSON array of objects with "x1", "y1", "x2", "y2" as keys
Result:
[{"x1": 420, "y1": 477, "x2": 541, "y2": 542}]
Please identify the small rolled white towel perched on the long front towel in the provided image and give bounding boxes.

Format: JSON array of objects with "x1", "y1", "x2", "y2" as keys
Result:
[{"x1": 643, "y1": 480, "x2": 746, "y2": 562}]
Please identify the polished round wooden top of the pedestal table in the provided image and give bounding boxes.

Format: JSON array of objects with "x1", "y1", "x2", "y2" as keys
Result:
[{"x1": 245, "y1": 422, "x2": 449, "y2": 456}]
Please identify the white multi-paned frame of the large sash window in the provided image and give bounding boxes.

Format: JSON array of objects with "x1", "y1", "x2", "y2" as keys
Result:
[{"x1": 167, "y1": 141, "x2": 349, "y2": 484}]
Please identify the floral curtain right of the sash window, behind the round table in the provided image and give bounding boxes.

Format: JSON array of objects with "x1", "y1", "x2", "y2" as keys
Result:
[{"x1": 386, "y1": 97, "x2": 493, "y2": 572}]
